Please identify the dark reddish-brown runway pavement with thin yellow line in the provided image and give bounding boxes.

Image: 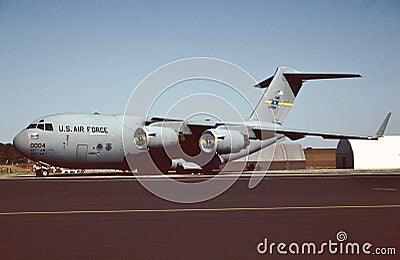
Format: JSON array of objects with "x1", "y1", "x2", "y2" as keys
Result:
[{"x1": 0, "y1": 173, "x2": 400, "y2": 259}]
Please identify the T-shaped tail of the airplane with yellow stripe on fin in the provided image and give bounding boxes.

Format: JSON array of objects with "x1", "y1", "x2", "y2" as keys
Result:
[{"x1": 250, "y1": 67, "x2": 361, "y2": 124}]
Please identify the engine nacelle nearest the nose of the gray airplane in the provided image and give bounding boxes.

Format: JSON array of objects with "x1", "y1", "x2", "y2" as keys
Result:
[{"x1": 133, "y1": 126, "x2": 179, "y2": 150}]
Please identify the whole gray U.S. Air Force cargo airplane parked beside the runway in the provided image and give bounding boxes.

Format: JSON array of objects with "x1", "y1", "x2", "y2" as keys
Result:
[{"x1": 13, "y1": 67, "x2": 390, "y2": 176}]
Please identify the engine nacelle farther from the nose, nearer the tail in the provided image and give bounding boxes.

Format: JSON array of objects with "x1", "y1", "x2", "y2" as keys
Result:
[{"x1": 199, "y1": 129, "x2": 249, "y2": 154}]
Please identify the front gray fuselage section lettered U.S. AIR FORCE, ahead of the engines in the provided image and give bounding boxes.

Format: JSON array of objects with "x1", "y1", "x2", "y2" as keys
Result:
[{"x1": 14, "y1": 114, "x2": 144, "y2": 169}]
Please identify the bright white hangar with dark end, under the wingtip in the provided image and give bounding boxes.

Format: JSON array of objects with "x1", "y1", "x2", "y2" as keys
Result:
[{"x1": 336, "y1": 136, "x2": 400, "y2": 169}]
